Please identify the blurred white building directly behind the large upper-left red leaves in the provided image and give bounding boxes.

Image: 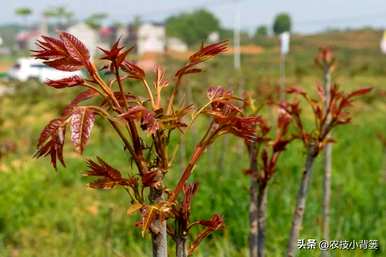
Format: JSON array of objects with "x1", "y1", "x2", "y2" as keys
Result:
[{"x1": 67, "y1": 22, "x2": 99, "y2": 56}]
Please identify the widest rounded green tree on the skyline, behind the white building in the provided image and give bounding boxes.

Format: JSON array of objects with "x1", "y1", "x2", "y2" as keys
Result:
[{"x1": 166, "y1": 9, "x2": 220, "y2": 45}]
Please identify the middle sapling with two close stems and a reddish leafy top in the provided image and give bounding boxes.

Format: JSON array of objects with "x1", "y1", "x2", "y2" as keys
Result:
[{"x1": 246, "y1": 95, "x2": 294, "y2": 257}]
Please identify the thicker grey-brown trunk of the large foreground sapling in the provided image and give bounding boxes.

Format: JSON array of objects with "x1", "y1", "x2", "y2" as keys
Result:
[{"x1": 149, "y1": 188, "x2": 168, "y2": 257}]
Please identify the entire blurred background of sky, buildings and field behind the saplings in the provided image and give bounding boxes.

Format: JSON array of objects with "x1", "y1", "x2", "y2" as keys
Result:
[{"x1": 0, "y1": 0, "x2": 386, "y2": 257}]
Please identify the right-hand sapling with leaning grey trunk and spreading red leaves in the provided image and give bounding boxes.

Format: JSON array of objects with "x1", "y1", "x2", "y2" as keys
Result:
[{"x1": 281, "y1": 80, "x2": 371, "y2": 257}]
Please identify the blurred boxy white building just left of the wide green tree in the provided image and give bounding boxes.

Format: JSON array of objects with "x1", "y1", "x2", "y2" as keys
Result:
[{"x1": 137, "y1": 23, "x2": 166, "y2": 55}]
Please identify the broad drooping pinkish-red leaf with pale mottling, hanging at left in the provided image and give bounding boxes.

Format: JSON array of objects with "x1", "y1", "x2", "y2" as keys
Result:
[{"x1": 71, "y1": 107, "x2": 95, "y2": 153}]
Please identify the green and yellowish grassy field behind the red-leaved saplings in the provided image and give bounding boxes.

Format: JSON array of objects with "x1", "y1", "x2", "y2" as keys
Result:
[{"x1": 0, "y1": 30, "x2": 386, "y2": 257}]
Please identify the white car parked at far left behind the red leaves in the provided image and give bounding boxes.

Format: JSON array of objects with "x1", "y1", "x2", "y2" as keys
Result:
[{"x1": 8, "y1": 58, "x2": 82, "y2": 82}]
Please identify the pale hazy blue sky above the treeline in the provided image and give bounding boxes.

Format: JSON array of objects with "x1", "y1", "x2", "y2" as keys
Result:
[{"x1": 4, "y1": 0, "x2": 386, "y2": 32}]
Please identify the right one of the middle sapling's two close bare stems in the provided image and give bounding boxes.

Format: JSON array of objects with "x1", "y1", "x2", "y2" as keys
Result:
[{"x1": 257, "y1": 183, "x2": 268, "y2": 257}]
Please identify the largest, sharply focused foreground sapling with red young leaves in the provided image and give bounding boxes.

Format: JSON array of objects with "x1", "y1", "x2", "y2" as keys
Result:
[{"x1": 34, "y1": 32, "x2": 258, "y2": 257}]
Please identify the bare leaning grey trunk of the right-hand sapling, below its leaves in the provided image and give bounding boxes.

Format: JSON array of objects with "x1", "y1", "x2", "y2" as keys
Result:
[{"x1": 287, "y1": 145, "x2": 317, "y2": 257}]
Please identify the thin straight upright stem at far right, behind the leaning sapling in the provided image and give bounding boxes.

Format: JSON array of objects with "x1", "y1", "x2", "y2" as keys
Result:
[{"x1": 321, "y1": 62, "x2": 332, "y2": 257}]
